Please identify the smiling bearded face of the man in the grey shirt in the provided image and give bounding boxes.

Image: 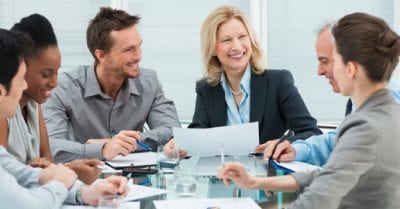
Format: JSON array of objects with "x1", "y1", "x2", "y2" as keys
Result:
[{"x1": 99, "y1": 25, "x2": 142, "y2": 78}]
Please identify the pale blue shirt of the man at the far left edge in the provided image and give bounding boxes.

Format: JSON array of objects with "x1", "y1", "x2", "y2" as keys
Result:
[{"x1": 0, "y1": 146, "x2": 82, "y2": 209}]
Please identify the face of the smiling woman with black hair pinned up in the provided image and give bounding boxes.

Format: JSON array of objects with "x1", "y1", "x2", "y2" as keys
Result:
[{"x1": 24, "y1": 46, "x2": 61, "y2": 104}]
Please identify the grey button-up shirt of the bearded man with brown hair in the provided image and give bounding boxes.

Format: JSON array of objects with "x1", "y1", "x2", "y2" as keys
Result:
[{"x1": 42, "y1": 65, "x2": 180, "y2": 162}]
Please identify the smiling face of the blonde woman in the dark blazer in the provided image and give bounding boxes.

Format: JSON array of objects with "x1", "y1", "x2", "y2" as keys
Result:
[{"x1": 215, "y1": 18, "x2": 252, "y2": 73}]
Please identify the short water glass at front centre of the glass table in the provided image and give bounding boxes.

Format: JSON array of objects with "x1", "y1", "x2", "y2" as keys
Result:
[{"x1": 175, "y1": 168, "x2": 197, "y2": 197}]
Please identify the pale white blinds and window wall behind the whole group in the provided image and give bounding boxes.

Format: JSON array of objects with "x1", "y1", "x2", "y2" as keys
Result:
[{"x1": 0, "y1": 0, "x2": 400, "y2": 122}]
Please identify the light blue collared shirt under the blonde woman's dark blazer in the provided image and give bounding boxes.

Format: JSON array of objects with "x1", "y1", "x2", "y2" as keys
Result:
[{"x1": 221, "y1": 65, "x2": 251, "y2": 126}]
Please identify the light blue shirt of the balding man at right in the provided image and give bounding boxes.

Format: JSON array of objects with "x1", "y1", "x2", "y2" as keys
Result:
[{"x1": 292, "y1": 79, "x2": 400, "y2": 166}]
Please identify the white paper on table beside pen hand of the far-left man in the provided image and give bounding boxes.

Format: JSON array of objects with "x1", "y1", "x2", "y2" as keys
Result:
[{"x1": 125, "y1": 181, "x2": 168, "y2": 201}]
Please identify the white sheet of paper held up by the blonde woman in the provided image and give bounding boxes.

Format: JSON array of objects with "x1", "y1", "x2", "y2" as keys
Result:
[{"x1": 173, "y1": 122, "x2": 259, "y2": 156}]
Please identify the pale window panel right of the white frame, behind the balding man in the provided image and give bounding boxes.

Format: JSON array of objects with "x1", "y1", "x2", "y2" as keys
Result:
[{"x1": 268, "y1": 0, "x2": 394, "y2": 122}]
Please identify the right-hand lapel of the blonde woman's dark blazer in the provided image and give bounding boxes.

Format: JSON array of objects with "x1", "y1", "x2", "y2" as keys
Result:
[{"x1": 250, "y1": 72, "x2": 268, "y2": 127}]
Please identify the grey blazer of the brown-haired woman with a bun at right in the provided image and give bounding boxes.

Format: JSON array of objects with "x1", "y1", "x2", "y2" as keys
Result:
[{"x1": 291, "y1": 89, "x2": 400, "y2": 209}]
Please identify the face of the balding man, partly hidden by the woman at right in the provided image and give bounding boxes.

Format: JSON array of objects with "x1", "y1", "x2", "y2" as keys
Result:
[{"x1": 315, "y1": 28, "x2": 340, "y2": 93}]
